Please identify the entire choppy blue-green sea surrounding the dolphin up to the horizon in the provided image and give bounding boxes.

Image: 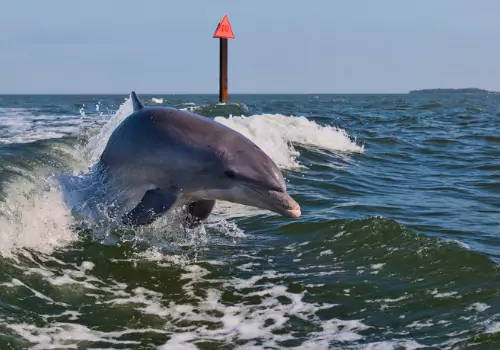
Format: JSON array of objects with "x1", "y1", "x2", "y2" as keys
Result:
[{"x1": 0, "y1": 94, "x2": 500, "y2": 350}]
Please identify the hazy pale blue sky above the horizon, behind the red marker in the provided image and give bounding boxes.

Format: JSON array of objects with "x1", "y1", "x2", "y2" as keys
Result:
[{"x1": 0, "y1": 0, "x2": 500, "y2": 94}]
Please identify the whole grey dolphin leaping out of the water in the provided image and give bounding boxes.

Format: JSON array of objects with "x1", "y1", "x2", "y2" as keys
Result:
[{"x1": 99, "y1": 92, "x2": 301, "y2": 226}]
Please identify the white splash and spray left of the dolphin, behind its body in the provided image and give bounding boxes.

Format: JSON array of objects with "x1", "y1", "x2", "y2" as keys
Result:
[{"x1": 0, "y1": 98, "x2": 137, "y2": 257}]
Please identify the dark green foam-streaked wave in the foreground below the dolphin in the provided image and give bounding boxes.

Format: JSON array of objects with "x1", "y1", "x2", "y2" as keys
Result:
[{"x1": 0, "y1": 217, "x2": 499, "y2": 349}]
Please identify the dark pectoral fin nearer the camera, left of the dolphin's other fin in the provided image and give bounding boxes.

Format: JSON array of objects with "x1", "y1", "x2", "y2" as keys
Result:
[{"x1": 122, "y1": 188, "x2": 178, "y2": 226}]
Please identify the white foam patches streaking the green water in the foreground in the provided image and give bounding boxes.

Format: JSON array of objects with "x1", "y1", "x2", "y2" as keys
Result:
[{"x1": 0, "y1": 257, "x2": 370, "y2": 349}]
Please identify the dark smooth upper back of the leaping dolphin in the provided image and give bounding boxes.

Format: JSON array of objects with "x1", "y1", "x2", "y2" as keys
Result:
[{"x1": 101, "y1": 107, "x2": 263, "y2": 164}]
